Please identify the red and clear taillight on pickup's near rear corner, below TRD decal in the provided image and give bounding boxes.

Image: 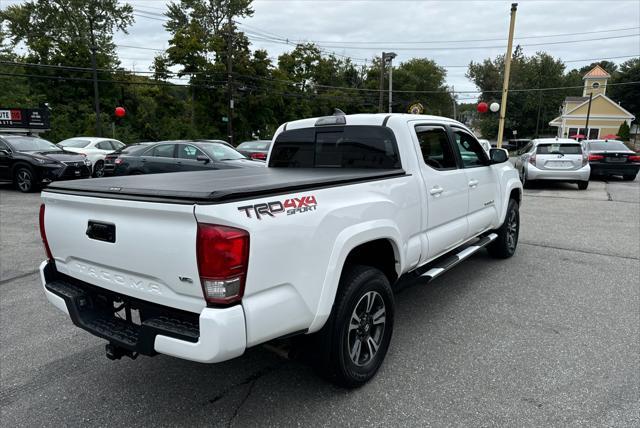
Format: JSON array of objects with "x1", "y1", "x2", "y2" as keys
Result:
[{"x1": 196, "y1": 223, "x2": 249, "y2": 304}]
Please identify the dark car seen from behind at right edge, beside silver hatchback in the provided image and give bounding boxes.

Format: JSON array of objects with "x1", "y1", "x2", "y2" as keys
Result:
[{"x1": 585, "y1": 140, "x2": 640, "y2": 181}]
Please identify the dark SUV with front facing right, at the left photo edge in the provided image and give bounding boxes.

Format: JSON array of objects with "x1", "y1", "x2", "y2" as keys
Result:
[{"x1": 0, "y1": 134, "x2": 91, "y2": 193}]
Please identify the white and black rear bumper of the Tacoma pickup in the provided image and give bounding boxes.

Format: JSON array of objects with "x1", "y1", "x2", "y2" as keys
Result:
[{"x1": 40, "y1": 262, "x2": 247, "y2": 363}]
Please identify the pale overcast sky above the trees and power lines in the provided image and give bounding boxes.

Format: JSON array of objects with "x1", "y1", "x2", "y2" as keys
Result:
[{"x1": 0, "y1": 0, "x2": 640, "y2": 98}]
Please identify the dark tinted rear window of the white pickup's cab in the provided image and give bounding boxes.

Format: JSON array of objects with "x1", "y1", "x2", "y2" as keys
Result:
[{"x1": 269, "y1": 125, "x2": 401, "y2": 169}]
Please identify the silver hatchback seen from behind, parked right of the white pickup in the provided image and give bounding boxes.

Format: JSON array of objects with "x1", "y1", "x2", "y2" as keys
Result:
[{"x1": 514, "y1": 138, "x2": 591, "y2": 190}]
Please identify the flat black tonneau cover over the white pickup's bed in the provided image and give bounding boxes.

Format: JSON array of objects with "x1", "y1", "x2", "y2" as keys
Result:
[{"x1": 44, "y1": 167, "x2": 406, "y2": 204}]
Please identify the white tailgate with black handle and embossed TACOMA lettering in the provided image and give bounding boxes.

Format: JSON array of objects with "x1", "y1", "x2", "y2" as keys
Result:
[{"x1": 42, "y1": 191, "x2": 206, "y2": 313}]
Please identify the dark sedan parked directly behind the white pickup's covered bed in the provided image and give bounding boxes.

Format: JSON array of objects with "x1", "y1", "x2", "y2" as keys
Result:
[{"x1": 105, "y1": 141, "x2": 264, "y2": 175}]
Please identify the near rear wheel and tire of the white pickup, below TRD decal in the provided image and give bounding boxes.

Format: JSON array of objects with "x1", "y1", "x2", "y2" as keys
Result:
[{"x1": 315, "y1": 265, "x2": 395, "y2": 388}]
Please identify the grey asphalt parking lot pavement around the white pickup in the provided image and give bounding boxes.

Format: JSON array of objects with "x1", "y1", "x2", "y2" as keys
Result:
[{"x1": 0, "y1": 179, "x2": 640, "y2": 427}]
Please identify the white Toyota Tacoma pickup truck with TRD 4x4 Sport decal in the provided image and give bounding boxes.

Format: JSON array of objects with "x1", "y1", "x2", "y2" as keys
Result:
[{"x1": 40, "y1": 114, "x2": 522, "y2": 387}]
